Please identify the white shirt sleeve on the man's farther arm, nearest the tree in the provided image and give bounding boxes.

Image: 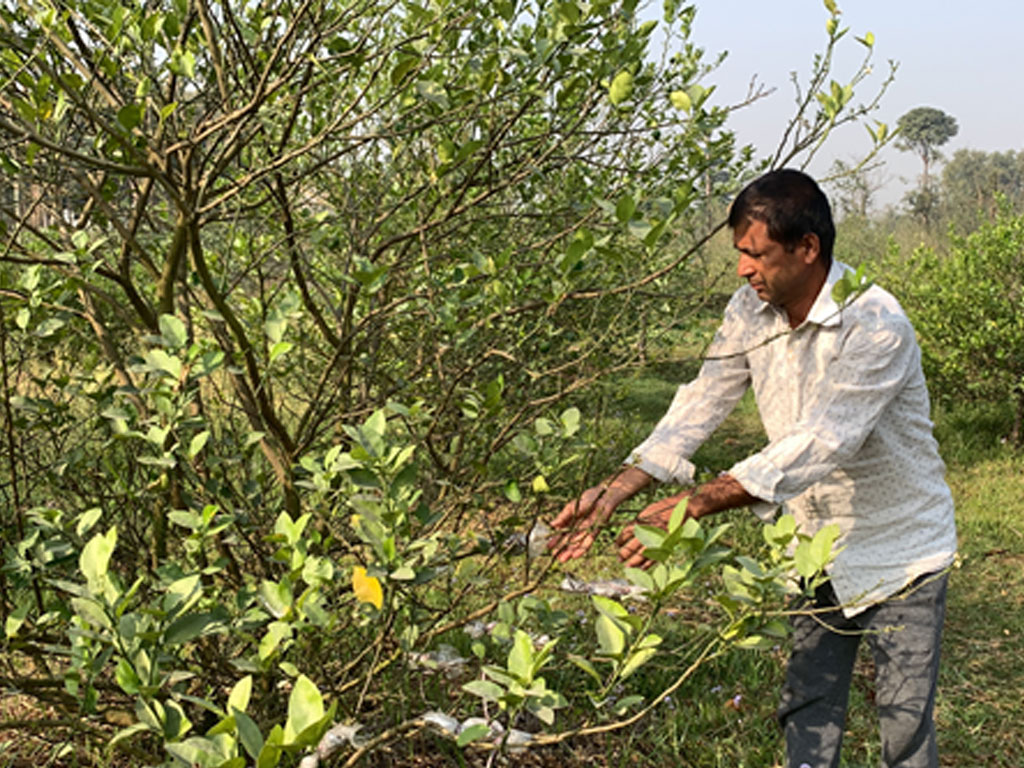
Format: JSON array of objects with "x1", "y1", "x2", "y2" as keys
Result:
[{"x1": 626, "y1": 293, "x2": 750, "y2": 484}]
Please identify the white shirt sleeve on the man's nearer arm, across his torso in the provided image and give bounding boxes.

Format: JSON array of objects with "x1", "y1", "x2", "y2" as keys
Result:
[{"x1": 729, "y1": 315, "x2": 920, "y2": 504}]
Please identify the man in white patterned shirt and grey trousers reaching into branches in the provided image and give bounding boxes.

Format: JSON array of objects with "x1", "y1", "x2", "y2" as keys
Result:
[{"x1": 549, "y1": 170, "x2": 956, "y2": 768}]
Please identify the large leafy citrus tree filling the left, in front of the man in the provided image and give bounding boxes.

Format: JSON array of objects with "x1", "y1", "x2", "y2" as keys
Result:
[{"x1": 0, "y1": 0, "x2": 886, "y2": 766}]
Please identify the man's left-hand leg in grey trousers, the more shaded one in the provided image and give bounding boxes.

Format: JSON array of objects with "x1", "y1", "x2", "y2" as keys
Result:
[{"x1": 778, "y1": 584, "x2": 862, "y2": 768}]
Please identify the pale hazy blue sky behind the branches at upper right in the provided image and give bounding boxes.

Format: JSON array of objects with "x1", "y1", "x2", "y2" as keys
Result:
[{"x1": 679, "y1": 0, "x2": 1024, "y2": 205}]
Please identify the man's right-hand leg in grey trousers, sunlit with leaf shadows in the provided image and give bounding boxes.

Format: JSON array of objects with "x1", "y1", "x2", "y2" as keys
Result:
[{"x1": 866, "y1": 572, "x2": 949, "y2": 768}]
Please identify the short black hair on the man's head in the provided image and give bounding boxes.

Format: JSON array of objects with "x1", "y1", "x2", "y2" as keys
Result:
[{"x1": 729, "y1": 168, "x2": 836, "y2": 267}]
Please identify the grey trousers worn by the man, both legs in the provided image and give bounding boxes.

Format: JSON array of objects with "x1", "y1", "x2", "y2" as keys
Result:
[{"x1": 778, "y1": 572, "x2": 949, "y2": 768}]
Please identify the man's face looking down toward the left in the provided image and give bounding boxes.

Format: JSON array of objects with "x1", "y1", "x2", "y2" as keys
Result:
[{"x1": 732, "y1": 219, "x2": 820, "y2": 313}]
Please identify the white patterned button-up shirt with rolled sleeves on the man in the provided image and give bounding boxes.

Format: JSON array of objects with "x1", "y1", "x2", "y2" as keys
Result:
[{"x1": 629, "y1": 262, "x2": 956, "y2": 615}]
